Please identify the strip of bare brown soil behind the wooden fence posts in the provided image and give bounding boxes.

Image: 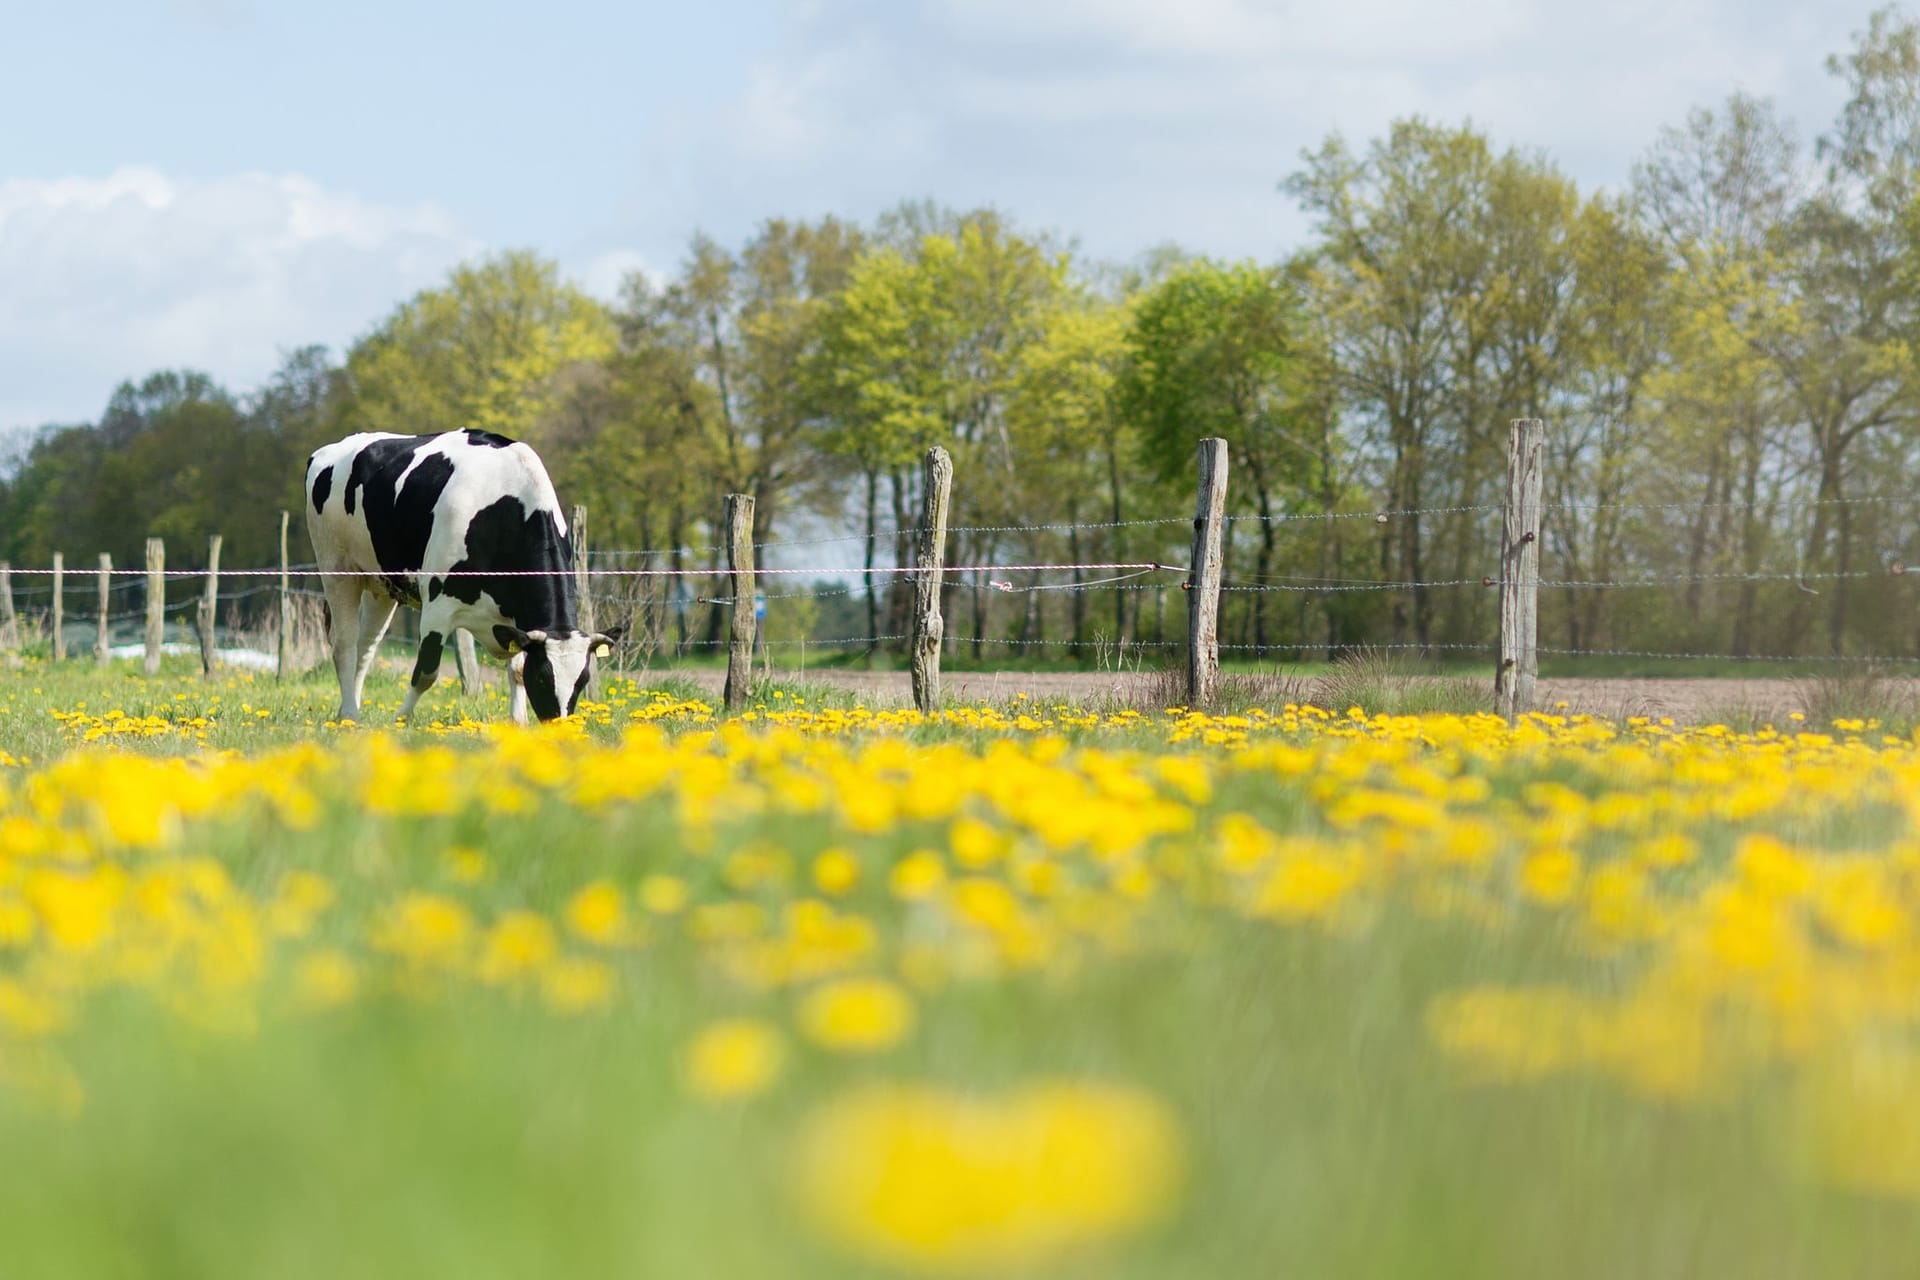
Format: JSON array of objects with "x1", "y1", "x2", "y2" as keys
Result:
[{"x1": 660, "y1": 670, "x2": 1858, "y2": 723}]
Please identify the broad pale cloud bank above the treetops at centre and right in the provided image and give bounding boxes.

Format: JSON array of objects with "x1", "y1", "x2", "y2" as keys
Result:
[{"x1": 657, "y1": 0, "x2": 1878, "y2": 257}]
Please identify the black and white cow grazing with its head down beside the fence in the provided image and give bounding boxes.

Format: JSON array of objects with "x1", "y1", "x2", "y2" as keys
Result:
[{"x1": 307, "y1": 430, "x2": 612, "y2": 723}]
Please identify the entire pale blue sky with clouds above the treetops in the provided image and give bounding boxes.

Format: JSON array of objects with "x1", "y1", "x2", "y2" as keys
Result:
[{"x1": 0, "y1": 0, "x2": 1896, "y2": 432}]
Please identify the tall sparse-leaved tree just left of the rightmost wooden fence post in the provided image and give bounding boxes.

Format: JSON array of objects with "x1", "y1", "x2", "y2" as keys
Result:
[{"x1": 1284, "y1": 119, "x2": 1578, "y2": 645}]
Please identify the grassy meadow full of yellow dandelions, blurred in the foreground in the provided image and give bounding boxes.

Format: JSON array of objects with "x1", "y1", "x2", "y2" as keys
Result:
[{"x1": 0, "y1": 668, "x2": 1920, "y2": 1276}]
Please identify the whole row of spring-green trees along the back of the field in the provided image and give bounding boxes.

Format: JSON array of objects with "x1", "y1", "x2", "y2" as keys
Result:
[{"x1": 11, "y1": 8, "x2": 1920, "y2": 656}]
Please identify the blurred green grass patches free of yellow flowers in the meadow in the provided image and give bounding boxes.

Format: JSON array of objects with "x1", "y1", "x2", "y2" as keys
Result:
[{"x1": 0, "y1": 662, "x2": 1920, "y2": 1280}]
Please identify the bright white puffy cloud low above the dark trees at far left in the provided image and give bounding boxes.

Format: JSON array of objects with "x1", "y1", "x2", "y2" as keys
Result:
[{"x1": 0, "y1": 167, "x2": 482, "y2": 426}]
